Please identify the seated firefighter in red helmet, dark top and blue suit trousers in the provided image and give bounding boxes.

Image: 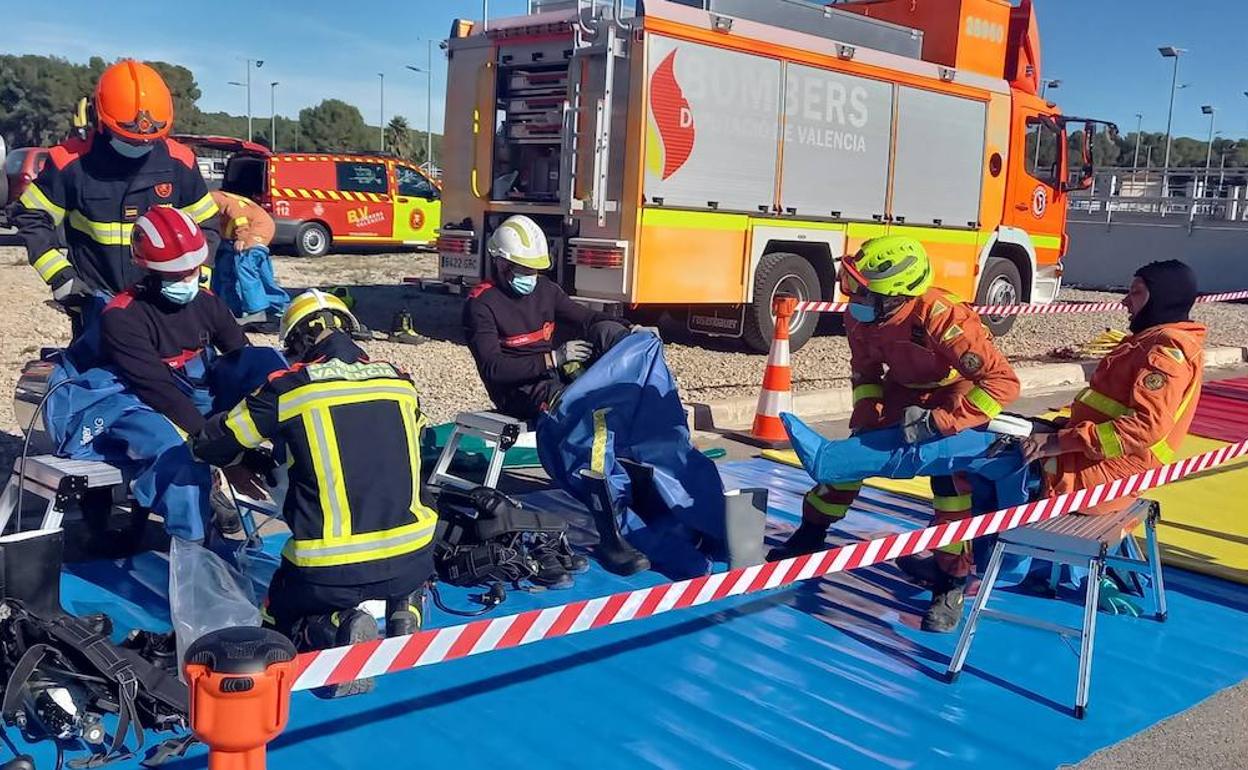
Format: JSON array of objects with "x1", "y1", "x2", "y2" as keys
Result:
[{"x1": 44, "y1": 206, "x2": 285, "y2": 542}]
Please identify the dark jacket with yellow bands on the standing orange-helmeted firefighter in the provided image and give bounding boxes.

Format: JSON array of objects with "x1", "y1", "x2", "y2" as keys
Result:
[{"x1": 11, "y1": 134, "x2": 220, "y2": 295}]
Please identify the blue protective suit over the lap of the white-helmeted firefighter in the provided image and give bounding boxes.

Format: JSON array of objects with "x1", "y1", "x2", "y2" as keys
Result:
[{"x1": 537, "y1": 333, "x2": 724, "y2": 579}]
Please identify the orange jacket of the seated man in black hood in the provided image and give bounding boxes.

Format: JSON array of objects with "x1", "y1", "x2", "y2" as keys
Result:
[{"x1": 1046, "y1": 321, "x2": 1206, "y2": 494}]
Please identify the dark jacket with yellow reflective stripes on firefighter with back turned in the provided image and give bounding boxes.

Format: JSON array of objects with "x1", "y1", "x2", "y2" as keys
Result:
[{"x1": 192, "y1": 333, "x2": 437, "y2": 585}]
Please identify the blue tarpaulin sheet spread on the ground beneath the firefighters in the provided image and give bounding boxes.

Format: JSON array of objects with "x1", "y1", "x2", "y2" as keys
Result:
[{"x1": 24, "y1": 459, "x2": 1248, "y2": 770}]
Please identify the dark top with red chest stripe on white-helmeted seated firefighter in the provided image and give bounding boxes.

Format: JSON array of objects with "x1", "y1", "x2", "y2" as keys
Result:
[{"x1": 464, "y1": 276, "x2": 612, "y2": 412}]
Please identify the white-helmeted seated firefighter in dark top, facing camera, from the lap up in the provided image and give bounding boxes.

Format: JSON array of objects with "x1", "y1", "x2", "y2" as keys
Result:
[{"x1": 464, "y1": 215, "x2": 654, "y2": 421}]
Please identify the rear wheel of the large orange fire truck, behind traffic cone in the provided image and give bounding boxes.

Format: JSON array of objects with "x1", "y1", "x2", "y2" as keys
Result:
[{"x1": 745, "y1": 252, "x2": 822, "y2": 353}]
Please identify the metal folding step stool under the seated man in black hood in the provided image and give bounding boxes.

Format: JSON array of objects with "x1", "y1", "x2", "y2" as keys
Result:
[{"x1": 946, "y1": 499, "x2": 1166, "y2": 719}]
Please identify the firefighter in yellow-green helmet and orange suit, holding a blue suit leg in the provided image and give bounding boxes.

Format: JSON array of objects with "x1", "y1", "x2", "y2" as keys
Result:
[{"x1": 769, "y1": 236, "x2": 1018, "y2": 631}]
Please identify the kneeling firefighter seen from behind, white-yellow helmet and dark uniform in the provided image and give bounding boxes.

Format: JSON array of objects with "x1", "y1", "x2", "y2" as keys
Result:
[{"x1": 193, "y1": 290, "x2": 437, "y2": 696}]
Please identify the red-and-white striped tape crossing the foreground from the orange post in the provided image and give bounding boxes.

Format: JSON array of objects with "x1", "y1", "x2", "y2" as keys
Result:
[{"x1": 287, "y1": 441, "x2": 1248, "y2": 690}]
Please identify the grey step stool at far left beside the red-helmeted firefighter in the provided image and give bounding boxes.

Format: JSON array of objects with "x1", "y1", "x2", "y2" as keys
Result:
[{"x1": 0, "y1": 454, "x2": 122, "y2": 533}]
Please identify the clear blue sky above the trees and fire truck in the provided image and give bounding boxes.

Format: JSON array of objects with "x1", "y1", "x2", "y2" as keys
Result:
[{"x1": 9, "y1": 0, "x2": 1248, "y2": 137}]
